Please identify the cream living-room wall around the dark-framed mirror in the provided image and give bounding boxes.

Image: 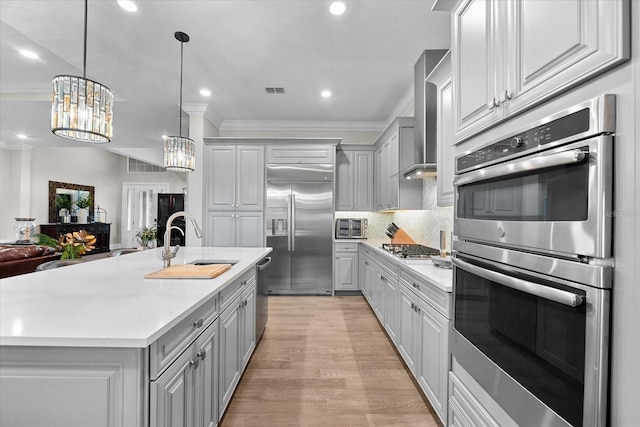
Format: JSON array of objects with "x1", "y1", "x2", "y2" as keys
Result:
[{"x1": 0, "y1": 147, "x2": 186, "y2": 247}]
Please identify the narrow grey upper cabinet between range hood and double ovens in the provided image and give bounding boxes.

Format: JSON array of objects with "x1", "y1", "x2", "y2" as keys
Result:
[{"x1": 426, "y1": 52, "x2": 455, "y2": 206}]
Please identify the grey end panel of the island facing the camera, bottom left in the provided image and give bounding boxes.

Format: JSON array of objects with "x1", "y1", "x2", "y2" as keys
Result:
[{"x1": 0, "y1": 347, "x2": 144, "y2": 427}]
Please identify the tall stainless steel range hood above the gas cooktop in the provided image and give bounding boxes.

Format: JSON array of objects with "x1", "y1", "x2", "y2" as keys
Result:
[{"x1": 400, "y1": 50, "x2": 447, "y2": 179}]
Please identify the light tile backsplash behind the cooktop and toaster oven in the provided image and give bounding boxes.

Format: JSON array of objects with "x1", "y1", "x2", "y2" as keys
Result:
[{"x1": 335, "y1": 178, "x2": 453, "y2": 251}]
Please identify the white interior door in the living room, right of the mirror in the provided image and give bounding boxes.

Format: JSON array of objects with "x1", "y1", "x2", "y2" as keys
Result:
[{"x1": 120, "y1": 182, "x2": 169, "y2": 248}]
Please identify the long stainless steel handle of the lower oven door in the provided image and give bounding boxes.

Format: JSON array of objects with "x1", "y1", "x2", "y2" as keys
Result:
[{"x1": 452, "y1": 258, "x2": 584, "y2": 307}]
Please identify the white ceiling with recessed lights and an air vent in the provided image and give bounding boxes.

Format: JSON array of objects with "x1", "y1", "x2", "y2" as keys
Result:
[{"x1": 0, "y1": 0, "x2": 450, "y2": 164}]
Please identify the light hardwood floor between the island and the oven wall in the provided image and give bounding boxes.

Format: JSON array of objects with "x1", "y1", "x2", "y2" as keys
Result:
[{"x1": 220, "y1": 296, "x2": 441, "y2": 427}]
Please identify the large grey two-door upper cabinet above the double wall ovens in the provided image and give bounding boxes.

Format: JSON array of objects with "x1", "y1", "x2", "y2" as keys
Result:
[{"x1": 451, "y1": 0, "x2": 630, "y2": 142}]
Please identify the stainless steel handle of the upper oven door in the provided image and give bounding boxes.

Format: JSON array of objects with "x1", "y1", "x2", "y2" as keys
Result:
[{"x1": 453, "y1": 149, "x2": 585, "y2": 187}]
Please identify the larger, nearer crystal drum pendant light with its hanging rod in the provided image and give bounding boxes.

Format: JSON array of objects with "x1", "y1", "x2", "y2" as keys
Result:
[{"x1": 51, "y1": 0, "x2": 113, "y2": 143}]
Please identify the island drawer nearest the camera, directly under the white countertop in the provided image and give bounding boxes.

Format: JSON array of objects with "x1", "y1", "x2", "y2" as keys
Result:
[{"x1": 149, "y1": 295, "x2": 220, "y2": 380}]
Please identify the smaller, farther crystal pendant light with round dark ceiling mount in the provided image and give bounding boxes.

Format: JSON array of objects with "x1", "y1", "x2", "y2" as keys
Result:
[{"x1": 164, "y1": 31, "x2": 196, "y2": 172}]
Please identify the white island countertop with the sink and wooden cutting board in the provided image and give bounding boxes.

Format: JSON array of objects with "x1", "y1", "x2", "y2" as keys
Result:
[{"x1": 0, "y1": 247, "x2": 271, "y2": 348}]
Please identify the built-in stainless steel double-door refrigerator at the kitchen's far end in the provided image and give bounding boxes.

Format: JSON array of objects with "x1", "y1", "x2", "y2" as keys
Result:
[{"x1": 265, "y1": 164, "x2": 333, "y2": 295}]
